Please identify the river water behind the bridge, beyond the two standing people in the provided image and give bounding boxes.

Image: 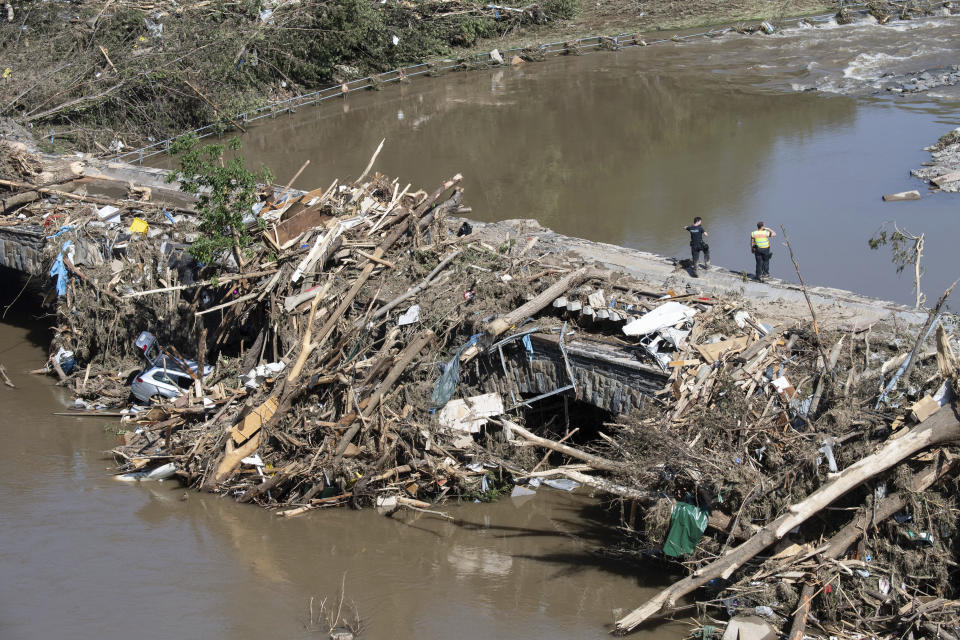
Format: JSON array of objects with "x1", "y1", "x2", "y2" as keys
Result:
[{"x1": 227, "y1": 17, "x2": 960, "y2": 303}]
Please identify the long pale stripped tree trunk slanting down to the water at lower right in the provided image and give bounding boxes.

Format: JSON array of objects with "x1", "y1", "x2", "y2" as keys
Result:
[{"x1": 616, "y1": 405, "x2": 960, "y2": 632}]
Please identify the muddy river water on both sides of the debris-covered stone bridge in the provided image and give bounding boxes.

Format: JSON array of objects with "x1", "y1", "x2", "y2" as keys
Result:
[{"x1": 0, "y1": 13, "x2": 960, "y2": 639}]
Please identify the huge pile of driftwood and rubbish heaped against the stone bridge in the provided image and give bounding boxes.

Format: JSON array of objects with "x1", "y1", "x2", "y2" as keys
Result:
[{"x1": 2, "y1": 144, "x2": 960, "y2": 639}]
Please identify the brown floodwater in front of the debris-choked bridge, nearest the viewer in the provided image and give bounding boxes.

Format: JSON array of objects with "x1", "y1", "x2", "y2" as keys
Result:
[{"x1": 0, "y1": 282, "x2": 686, "y2": 640}]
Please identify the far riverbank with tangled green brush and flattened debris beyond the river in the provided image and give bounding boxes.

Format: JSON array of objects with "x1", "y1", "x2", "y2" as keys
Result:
[{"x1": 0, "y1": 0, "x2": 956, "y2": 155}]
